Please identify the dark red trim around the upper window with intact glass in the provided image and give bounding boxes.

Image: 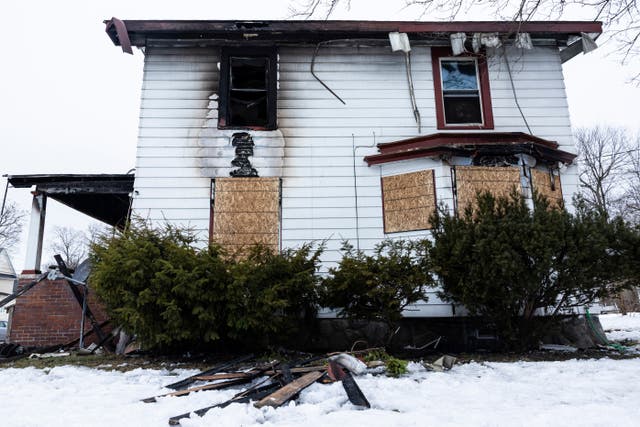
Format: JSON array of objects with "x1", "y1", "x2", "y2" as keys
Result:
[{"x1": 431, "y1": 47, "x2": 493, "y2": 130}]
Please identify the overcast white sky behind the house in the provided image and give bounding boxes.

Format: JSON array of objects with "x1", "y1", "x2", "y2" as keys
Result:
[{"x1": 0, "y1": 0, "x2": 640, "y2": 271}]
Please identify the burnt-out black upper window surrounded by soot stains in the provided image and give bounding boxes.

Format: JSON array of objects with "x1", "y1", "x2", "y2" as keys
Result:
[{"x1": 218, "y1": 48, "x2": 277, "y2": 129}]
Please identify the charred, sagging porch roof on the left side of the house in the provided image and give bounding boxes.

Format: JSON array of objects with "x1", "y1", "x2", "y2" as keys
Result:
[{"x1": 8, "y1": 174, "x2": 134, "y2": 227}]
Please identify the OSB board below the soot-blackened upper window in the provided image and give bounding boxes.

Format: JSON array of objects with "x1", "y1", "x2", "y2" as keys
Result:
[{"x1": 211, "y1": 178, "x2": 280, "y2": 251}]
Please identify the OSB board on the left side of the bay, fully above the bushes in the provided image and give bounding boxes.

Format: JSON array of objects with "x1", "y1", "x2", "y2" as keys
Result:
[{"x1": 382, "y1": 170, "x2": 436, "y2": 233}]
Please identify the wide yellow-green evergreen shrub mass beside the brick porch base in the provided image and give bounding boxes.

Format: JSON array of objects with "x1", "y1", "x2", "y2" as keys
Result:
[{"x1": 91, "y1": 223, "x2": 322, "y2": 348}]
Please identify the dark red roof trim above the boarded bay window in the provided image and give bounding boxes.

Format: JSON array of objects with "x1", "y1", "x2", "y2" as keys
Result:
[{"x1": 364, "y1": 132, "x2": 577, "y2": 166}]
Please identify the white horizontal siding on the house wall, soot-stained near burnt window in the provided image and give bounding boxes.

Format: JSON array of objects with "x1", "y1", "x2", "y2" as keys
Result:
[{"x1": 133, "y1": 42, "x2": 576, "y2": 315}]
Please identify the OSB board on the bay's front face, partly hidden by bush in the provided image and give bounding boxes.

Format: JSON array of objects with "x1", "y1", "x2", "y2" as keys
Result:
[{"x1": 456, "y1": 166, "x2": 521, "y2": 214}]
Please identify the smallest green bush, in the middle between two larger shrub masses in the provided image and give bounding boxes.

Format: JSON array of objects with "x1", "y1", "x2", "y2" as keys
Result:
[{"x1": 321, "y1": 240, "x2": 433, "y2": 326}]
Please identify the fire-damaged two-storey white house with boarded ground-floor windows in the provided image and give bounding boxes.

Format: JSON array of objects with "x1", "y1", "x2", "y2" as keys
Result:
[{"x1": 10, "y1": 18, "x2": 601, "y2": 348}]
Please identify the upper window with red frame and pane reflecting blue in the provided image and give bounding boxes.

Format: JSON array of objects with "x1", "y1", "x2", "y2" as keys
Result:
[{"x1": 431, "y1": 48, "x2": 493, "y2": 129}]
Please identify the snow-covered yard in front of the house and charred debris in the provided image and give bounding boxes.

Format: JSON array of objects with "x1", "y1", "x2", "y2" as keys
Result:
[{"x1": 0, "y1": 314, "x2": 640, "y2": 427}]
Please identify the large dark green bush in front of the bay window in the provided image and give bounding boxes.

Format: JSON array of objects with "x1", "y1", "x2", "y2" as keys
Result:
[{"x1": 431, "y1": 193, "x2": 638, "y2": 348}]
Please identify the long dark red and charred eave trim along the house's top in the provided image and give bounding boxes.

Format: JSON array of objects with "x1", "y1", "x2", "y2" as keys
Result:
[{"x1": 104, "y1": 18, "x2": 602, "y2": 47}]
